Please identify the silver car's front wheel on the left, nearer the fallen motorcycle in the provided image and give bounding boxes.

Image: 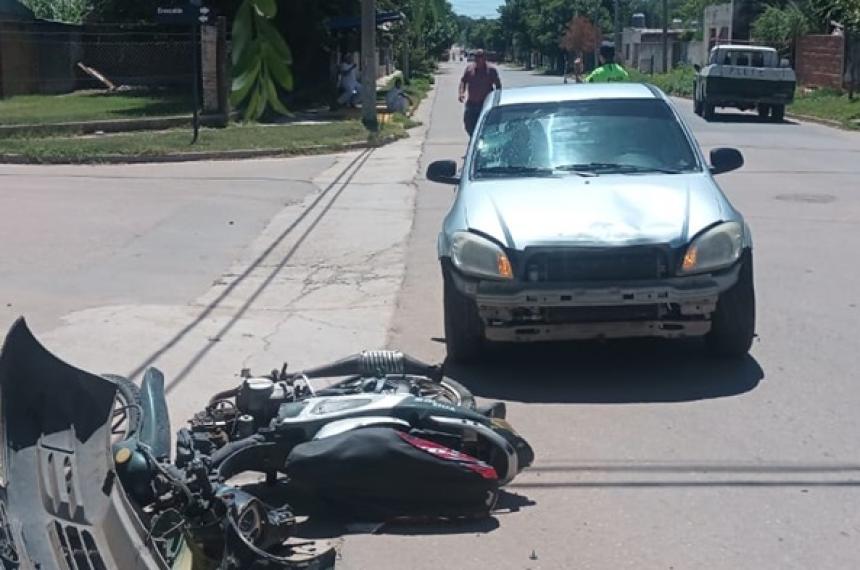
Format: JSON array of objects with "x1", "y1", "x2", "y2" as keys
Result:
[{"x1": 442, "y1": 269, "x2": 484, "y2": 362}]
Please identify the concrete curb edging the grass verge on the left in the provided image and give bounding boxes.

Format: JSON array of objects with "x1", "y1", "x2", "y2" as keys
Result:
[{"x1": 0, "y1": 135, "x2": 408, "y2": 164}]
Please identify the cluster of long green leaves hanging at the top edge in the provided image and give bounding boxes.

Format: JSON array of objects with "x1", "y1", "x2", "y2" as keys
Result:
[{"x1": 230, "y1": 0, "x2": 293, "y2": 121}]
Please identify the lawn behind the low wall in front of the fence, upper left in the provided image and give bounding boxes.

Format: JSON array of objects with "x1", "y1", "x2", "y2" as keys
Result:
[{"x1": 0, "y1": 91, "x2": 191, "y2": 125}]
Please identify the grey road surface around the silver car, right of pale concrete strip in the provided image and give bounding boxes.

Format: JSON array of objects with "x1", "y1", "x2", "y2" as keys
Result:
[{"x1": 344, "y1": 65, "x2": 860, "y2": 569}]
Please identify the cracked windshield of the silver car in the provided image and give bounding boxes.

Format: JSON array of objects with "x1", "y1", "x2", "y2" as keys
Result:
[{"x1": 473, "y1": 99, "x2": 699, "y2": 178}]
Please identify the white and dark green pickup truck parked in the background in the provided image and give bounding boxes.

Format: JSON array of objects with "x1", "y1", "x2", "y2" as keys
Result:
[{"x1": 693, "y1": 45, "x2": 797, "y2": 122}]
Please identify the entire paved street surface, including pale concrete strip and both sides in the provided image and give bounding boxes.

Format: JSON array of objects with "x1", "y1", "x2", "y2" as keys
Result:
[{"x1": 0, "y1": 64, "x2": 860, "y2": 570}]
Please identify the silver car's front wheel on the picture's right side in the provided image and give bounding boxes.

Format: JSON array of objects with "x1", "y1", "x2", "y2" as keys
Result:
[{"x1": 705, "y1": 252, "x2": 755, "y2": 357}]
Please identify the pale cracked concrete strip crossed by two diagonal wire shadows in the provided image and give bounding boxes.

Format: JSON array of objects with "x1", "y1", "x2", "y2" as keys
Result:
[{"x1": 36, "y1": 80, "x2": 431, "y2": 429}]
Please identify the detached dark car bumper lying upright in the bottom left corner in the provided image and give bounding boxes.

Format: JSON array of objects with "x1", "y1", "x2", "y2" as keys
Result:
[{"x1": 0, "y1": 320, "x2": 167, "y2": 570}]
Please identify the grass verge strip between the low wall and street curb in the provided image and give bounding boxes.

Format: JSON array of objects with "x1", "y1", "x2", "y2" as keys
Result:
[{"x1": 0, "y1": 121, "x2": 404, "y2": 162}]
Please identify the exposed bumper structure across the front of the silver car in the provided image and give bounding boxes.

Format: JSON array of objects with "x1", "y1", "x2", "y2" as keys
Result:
[{"x1": 452, "y1": 264, "x2": 740, "y2": 342}]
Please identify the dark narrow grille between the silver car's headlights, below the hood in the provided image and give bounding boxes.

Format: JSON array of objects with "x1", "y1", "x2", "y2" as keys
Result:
[{"x1": 523, "y1": 247, "x2": 668, "y2": 283}]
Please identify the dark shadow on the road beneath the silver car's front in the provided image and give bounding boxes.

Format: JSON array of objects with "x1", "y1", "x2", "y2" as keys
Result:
[{"x1": 445, "y1": 339, "x2": 764, "y2": 404}]
